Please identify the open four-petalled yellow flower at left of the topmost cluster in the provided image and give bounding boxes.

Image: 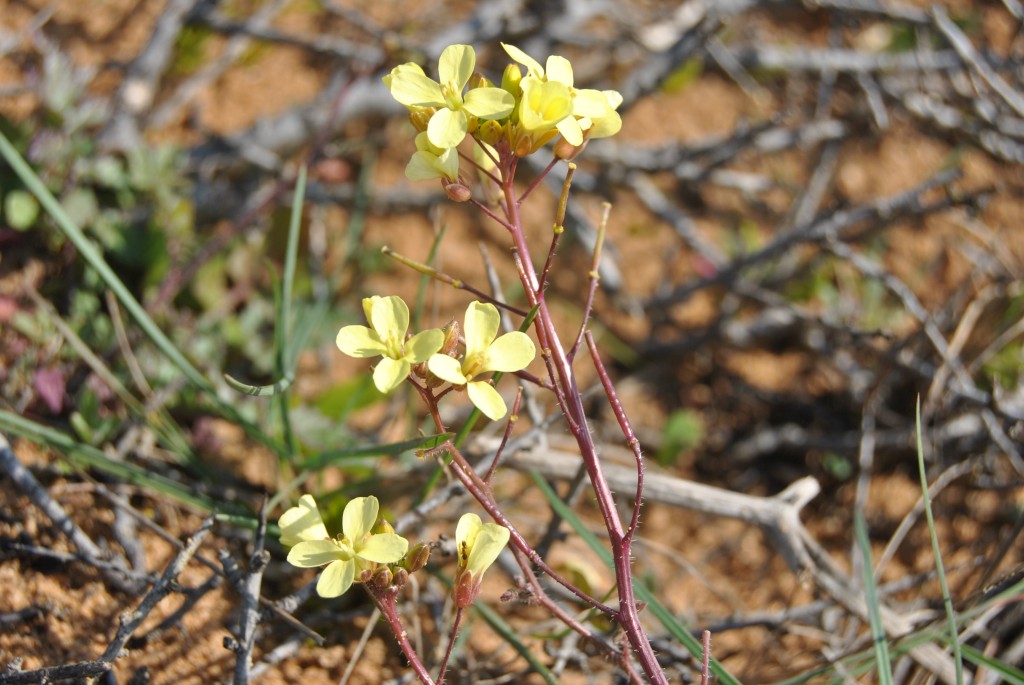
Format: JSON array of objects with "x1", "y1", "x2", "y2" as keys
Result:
[{"x1": 384, "y1": 45, "x2": 515, "y2": 148}]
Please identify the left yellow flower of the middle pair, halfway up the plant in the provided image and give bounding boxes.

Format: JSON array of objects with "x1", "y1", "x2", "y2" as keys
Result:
[{"x1": 336, "y1": 295, "x2": 444, "y2": 393}]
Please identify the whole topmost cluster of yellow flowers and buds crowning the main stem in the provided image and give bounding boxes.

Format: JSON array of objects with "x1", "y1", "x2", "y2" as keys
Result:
[{"x1": 384, "y1": 43, "x2": 623, "y2": 183}]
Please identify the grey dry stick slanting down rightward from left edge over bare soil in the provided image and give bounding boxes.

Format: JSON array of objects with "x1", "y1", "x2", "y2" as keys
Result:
[{"x1": 0, "y1": 433, "x2": 146, "y2": 595}]
